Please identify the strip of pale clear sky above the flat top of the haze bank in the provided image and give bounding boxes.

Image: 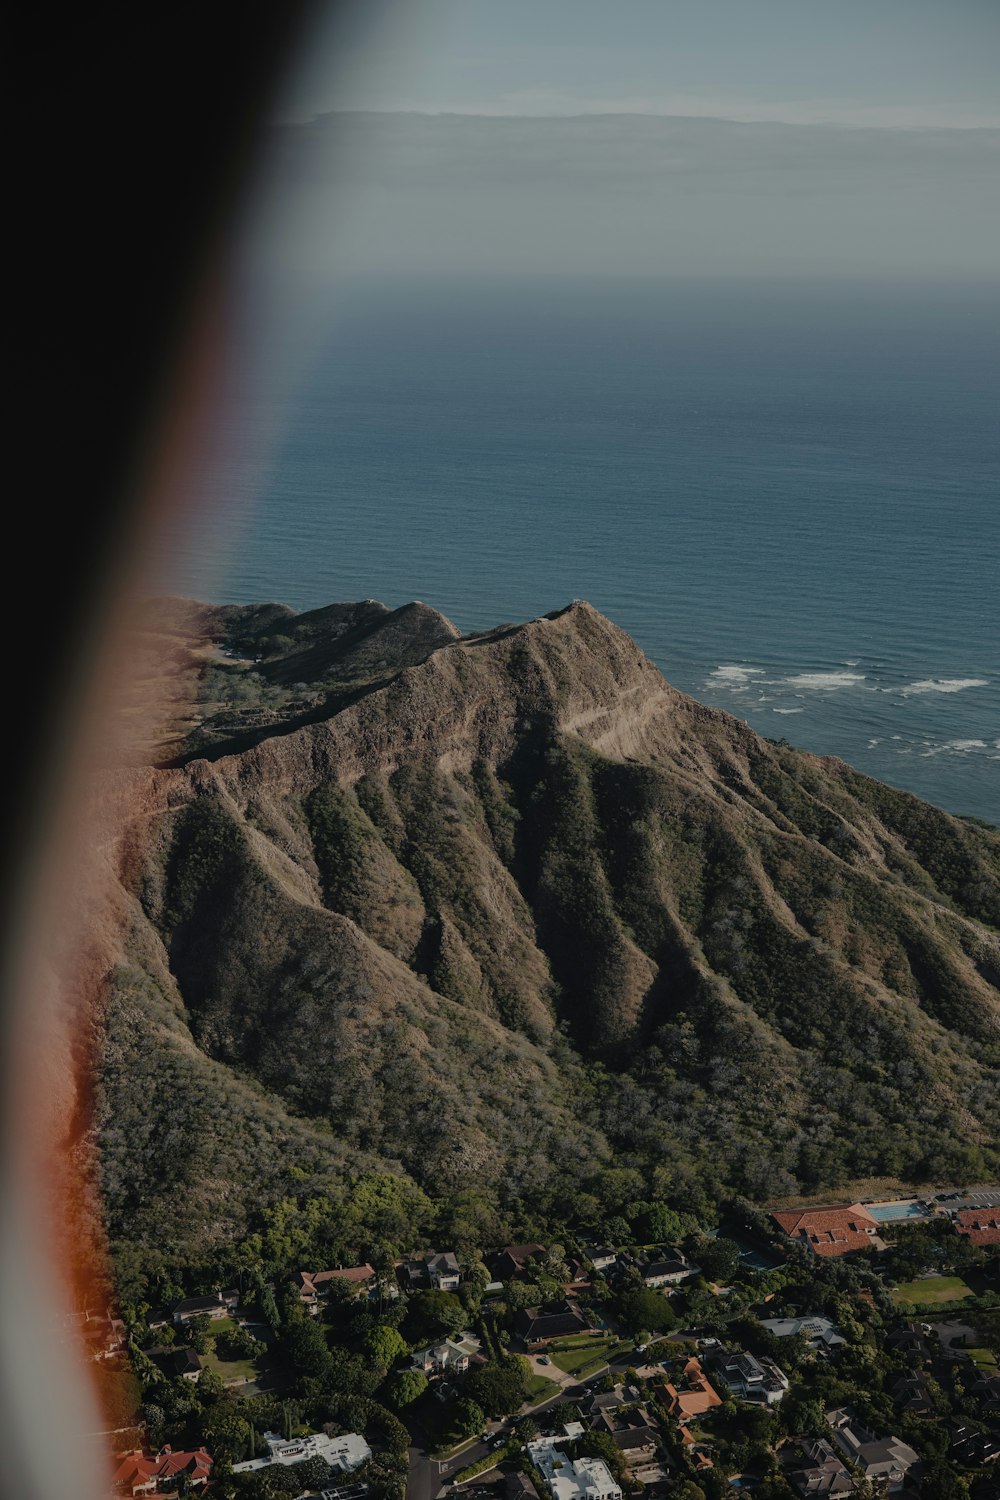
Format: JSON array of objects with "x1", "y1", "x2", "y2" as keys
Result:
[{"x1": 282, "y1": 0, "x2": 1000, "y2": 128}]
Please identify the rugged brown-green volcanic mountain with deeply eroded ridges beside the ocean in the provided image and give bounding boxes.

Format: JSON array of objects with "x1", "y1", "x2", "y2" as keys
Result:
[{"x1": 97, "y1": 600, "x2": 1000, "y2": 1284}]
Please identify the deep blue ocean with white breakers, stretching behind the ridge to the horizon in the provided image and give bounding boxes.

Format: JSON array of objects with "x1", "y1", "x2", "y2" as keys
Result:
[{"x1": 163, "y1": 282, "x2": 1000, "y2": 821}]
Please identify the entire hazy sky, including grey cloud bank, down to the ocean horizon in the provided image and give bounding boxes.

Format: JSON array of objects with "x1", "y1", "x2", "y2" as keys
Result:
[{"x1": 226, "y1": 0, "x2": 1000, "y2": 305}]
